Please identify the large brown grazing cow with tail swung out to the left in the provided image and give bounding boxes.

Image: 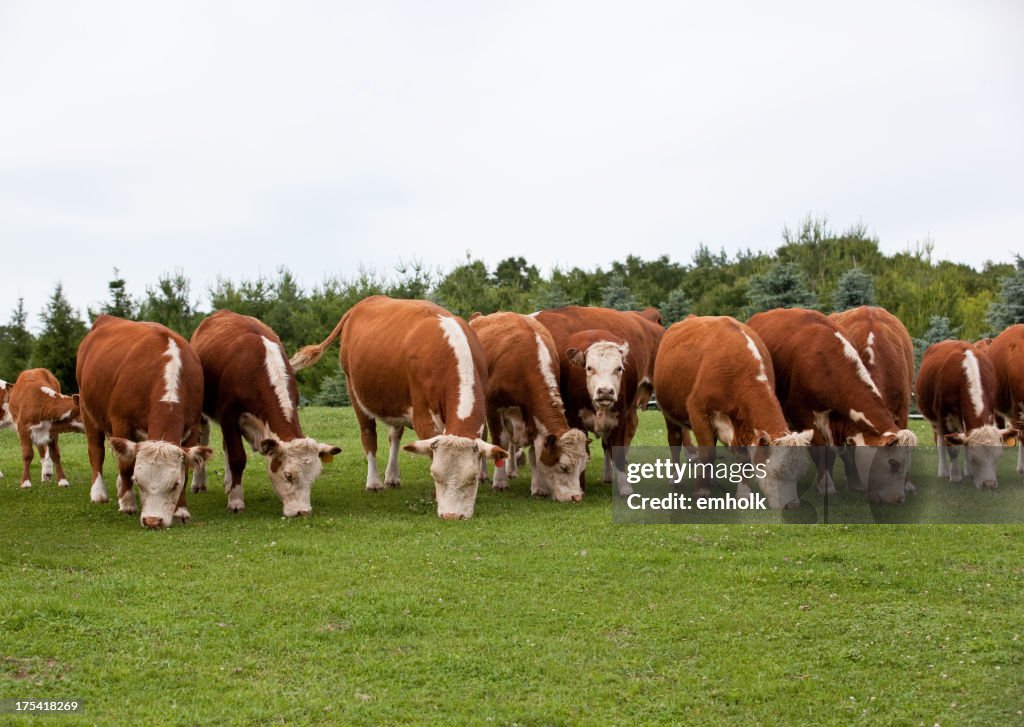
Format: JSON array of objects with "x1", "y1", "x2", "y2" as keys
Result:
[{"x1": 291, "y1": 295, "x2": 508, "y2": 520}]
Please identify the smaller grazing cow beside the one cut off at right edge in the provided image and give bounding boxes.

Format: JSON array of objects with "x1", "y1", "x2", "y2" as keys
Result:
[{"x1": 916, "y1": 341, "x2": 1017, "y2": 489}]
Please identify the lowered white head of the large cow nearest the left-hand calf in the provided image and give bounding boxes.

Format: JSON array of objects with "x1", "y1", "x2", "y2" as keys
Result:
[{"x1": 111, "y1": 437, "x2": 213, "y2": 528}]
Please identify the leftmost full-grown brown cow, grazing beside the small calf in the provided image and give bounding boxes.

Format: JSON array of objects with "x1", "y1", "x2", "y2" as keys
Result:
[{"x1": 77, "y1": 315, "x2": 213, "y2": 528}]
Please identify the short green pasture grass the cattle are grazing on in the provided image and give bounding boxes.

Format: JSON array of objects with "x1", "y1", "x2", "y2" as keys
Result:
[{"x1": 0, "y1": 409, "x2": 1024, "y2": 725}]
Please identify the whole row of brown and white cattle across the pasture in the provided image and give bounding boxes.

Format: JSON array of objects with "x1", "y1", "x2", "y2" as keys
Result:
[{"x1": 0, "y1": 296, "x2": 1024, "y2": 528}]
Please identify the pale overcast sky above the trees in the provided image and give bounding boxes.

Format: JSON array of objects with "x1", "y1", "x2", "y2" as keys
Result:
[{"x1": 0, "y1": 0, "x2": 1024, "y2": 331}]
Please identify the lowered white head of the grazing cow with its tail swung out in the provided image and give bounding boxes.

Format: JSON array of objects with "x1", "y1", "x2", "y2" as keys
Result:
[{"x1": 401, "y1": 434, "x2": 509, "y2": 520}]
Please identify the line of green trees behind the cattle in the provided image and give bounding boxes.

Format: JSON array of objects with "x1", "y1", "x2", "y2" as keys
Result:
[{"x1": 0, "y1": 218, "x2": 1024, "y2": 404}]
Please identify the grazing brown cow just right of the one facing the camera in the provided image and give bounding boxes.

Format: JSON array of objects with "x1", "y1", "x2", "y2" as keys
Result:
[{"x1": 654, "y1": 315, "x2": 813, "y2": 510}]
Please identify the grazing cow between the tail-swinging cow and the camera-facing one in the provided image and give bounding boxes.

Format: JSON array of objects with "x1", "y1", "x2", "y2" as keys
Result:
[{"x1": 469, "y1": 312, "x2": 590, "y2": 503}]
